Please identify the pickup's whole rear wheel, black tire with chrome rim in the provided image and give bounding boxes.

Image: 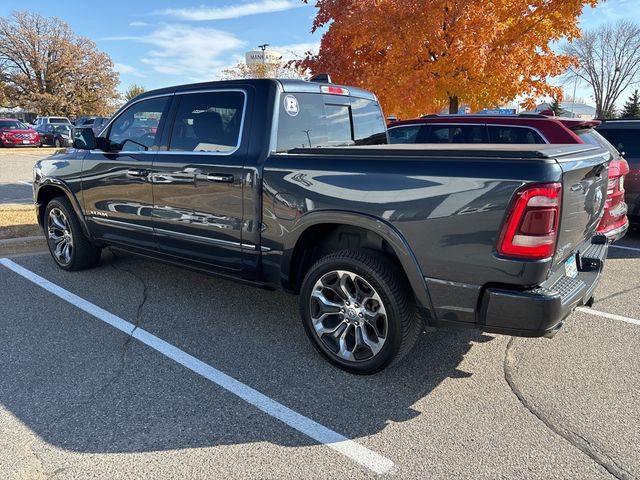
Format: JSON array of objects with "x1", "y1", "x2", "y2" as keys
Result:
[{"x1": 300, "y1": 249, "x2": 420, "y2": 375}]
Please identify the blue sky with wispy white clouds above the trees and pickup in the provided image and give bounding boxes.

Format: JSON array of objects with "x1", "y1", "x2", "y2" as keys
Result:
[{"x1": 0, "y1": 0, "x2": 640, "y2": 106}]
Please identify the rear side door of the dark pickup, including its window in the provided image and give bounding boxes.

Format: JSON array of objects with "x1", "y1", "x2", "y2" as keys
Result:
[{"x1": 153, "y1": 89, "x2": 249, "y2": 272}]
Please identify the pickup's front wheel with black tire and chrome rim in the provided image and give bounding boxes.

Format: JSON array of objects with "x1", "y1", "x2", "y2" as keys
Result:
[{"x1": 43, "y1": 197, "x2": 101, "y2": 271}]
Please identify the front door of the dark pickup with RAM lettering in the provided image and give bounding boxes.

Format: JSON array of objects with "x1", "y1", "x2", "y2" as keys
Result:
[{"x1": 82, "y1": 96, "x2": 171, "y2": 249}]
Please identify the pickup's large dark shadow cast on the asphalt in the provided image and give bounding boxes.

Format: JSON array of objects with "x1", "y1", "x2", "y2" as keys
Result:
[{"x1": 0, "y1": 254, "x2": 493, "y2": 452}]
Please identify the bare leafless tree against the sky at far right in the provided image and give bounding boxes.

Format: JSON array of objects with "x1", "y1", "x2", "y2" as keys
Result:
[{"x1": 564, "y1": 20, "x2": 640, "y2": 118}]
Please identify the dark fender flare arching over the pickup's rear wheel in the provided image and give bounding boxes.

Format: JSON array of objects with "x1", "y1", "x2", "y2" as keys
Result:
[{"x1": 281, "y1": 210, "x2": 435, "y2": 318}]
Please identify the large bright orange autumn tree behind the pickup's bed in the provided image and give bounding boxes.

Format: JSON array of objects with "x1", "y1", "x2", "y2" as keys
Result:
[{"x1": 299, "y1": 0, "x2": 597, "y2": 117}]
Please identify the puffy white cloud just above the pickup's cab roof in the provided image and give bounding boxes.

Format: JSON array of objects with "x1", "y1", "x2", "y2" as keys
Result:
[{"x1": 108, "y1": 25, "x2": 246, "y2": 81}]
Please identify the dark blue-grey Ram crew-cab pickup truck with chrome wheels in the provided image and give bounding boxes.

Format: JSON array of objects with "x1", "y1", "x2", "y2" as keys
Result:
[{"x1": 33, "y1": 79, "x2": 610, "y2": 373}]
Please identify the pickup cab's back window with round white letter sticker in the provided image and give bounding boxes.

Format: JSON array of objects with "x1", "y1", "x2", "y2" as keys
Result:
[{"x1": 276, "y1": 93, "x2": 387, "y2": 152}]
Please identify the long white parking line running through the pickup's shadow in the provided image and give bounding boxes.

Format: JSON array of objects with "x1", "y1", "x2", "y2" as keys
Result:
[{"x1": 0, "y1": 258, "x2": 393, "y2": 474}]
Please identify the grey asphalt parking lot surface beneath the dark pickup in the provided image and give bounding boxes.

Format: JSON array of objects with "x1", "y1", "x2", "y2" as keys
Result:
[{"x1": 0, "y1": 152, "x2": 640, "y2": 479}]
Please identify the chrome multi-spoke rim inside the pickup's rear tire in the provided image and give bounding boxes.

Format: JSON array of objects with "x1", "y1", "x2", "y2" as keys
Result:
[{"x1": 310, "y1": 270, "x2": 388, "y2": 362}]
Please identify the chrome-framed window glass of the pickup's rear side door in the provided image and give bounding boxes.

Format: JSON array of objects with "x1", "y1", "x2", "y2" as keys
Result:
[{"x1": 169, "y1": 91, "x2": 244, "y2": 153}]
